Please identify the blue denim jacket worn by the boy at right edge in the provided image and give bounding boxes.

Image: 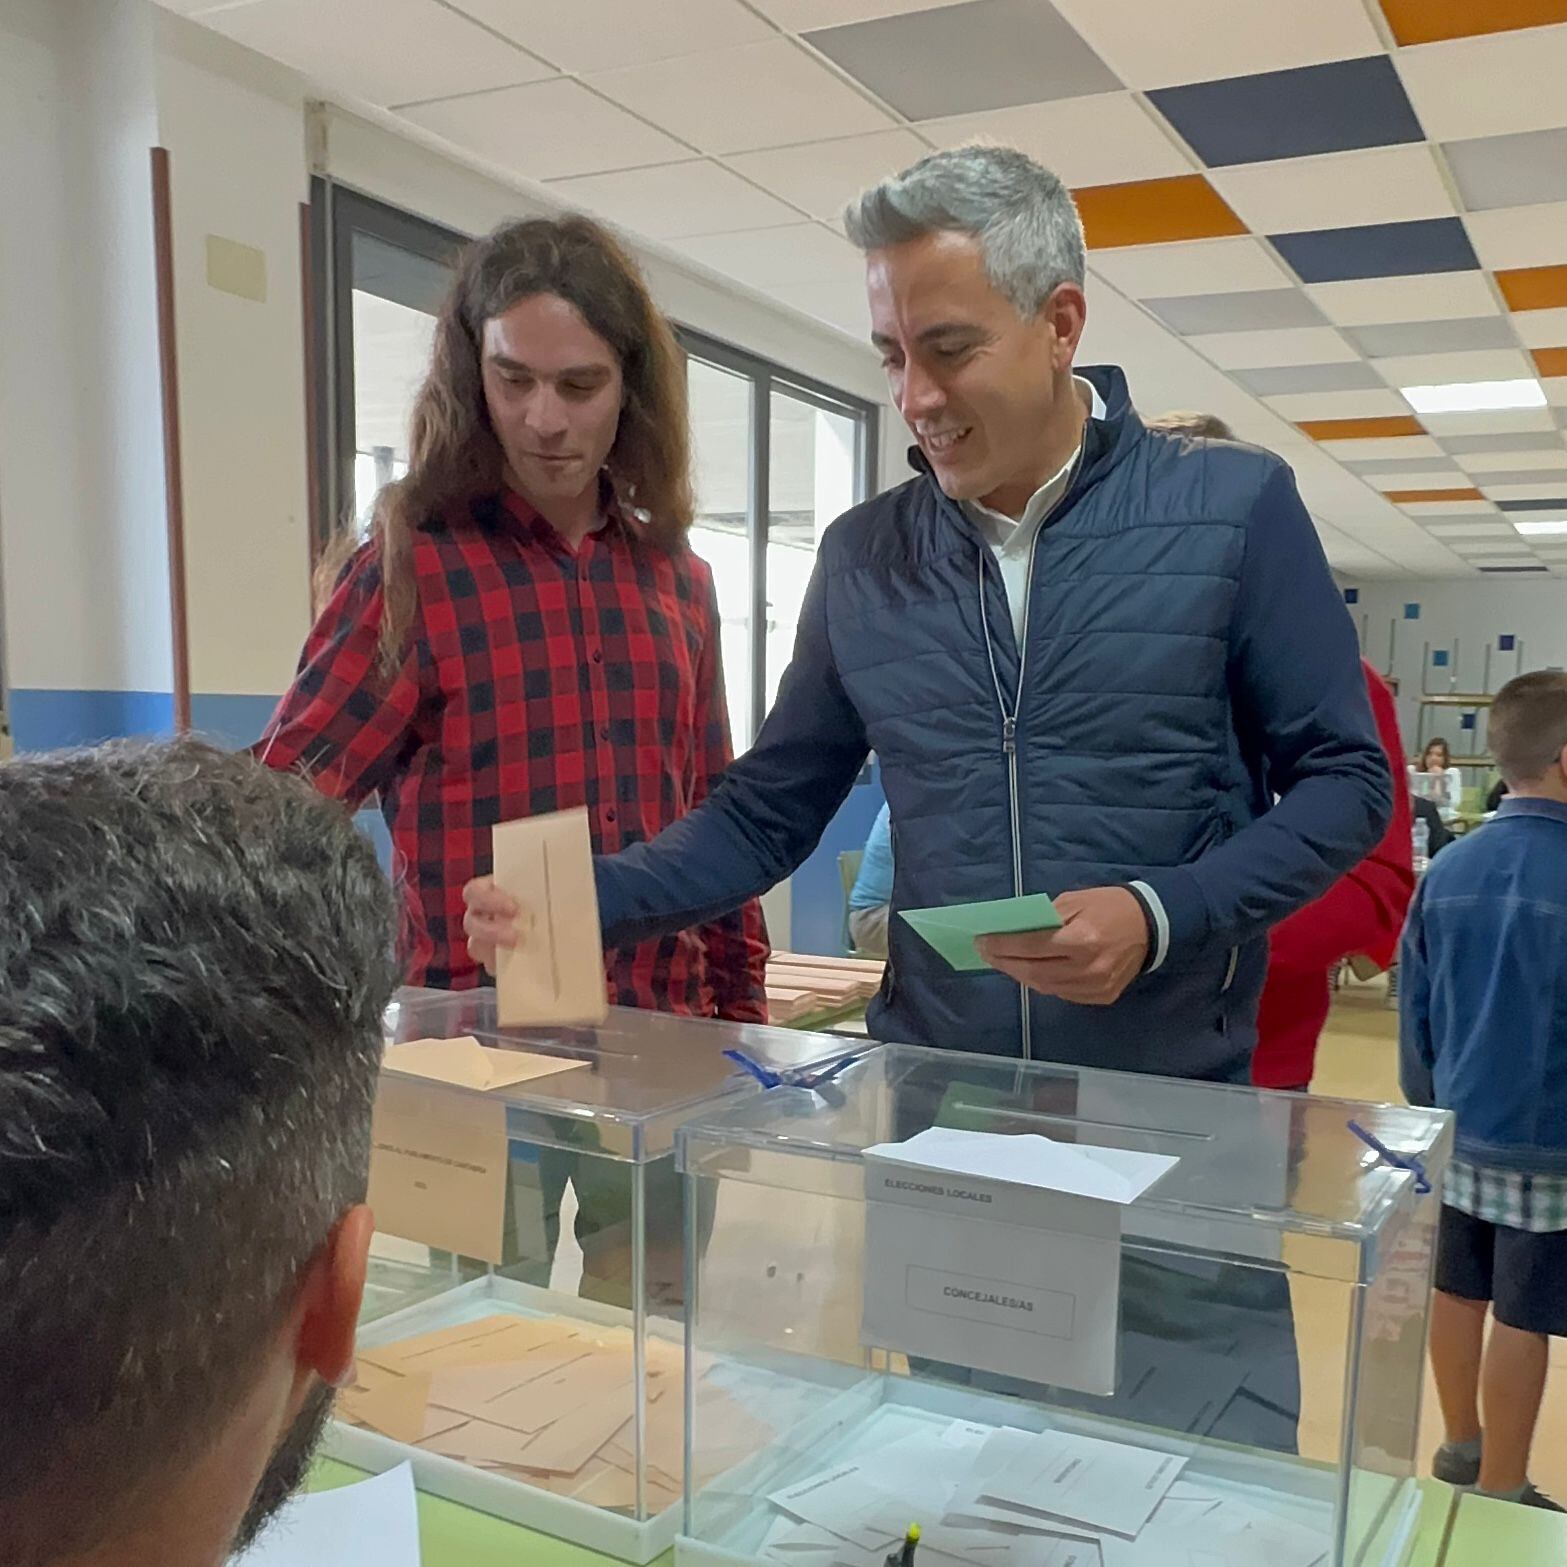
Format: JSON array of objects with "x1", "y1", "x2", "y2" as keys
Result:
[{"x1": 1399, "y1": 796, "x2": 1567, "y2": 1175}]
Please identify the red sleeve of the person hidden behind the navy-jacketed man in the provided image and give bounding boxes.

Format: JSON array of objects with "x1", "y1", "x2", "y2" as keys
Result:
[{"x1": 1269, "y1": 660, "x2": 1415, "y2": 973}]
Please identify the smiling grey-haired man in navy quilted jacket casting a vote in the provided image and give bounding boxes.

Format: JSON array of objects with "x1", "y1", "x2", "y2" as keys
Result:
[{"x1": 467, "y1": 146, "x2": 1391, "y2": 1083}]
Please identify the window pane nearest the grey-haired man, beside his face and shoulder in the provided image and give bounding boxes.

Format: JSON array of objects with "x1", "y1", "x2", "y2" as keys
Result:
[{"x1": 763, "y1": 390, "x2": 859, "y2": 707}]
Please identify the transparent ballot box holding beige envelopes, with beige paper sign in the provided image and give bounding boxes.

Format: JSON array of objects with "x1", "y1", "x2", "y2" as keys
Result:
[{"x1": 329, "y1": 990, "x2": 852, "y2": 1562}]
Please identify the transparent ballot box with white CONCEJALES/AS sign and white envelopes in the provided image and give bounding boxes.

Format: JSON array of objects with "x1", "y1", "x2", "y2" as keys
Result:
[{"x1": 677, "y1": 1045, "x2": 1453, "y2": 1567}]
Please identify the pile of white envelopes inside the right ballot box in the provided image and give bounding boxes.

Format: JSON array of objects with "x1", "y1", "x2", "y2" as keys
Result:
[{"x1": 762, "y1": 1421, "x2": 1329, "y2": 1567}]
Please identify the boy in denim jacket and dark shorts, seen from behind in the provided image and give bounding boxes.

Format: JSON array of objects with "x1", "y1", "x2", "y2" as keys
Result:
[{"x1": 1399, "y1": 671, "x2": 1567, "y2": 1512}]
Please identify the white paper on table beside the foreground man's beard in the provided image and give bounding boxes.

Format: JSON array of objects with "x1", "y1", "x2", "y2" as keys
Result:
[{"x1": 237, "y1": 1464, "x2": 420, "y2": 1567}]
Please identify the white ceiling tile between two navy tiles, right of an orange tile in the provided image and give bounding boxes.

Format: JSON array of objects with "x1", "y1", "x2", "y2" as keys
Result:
[{"x1": 1208, "y1": 143, "x2": 1453, "y2": 233}]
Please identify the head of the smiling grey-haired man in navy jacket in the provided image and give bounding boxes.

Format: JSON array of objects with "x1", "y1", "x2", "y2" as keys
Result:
[{"x1": 845, "y1": 146, "x2": 1087, "y2": 516}]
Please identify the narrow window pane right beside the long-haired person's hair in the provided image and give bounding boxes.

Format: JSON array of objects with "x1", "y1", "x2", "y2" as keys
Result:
[{"x1": 688, "y1": 359, "x2": 754, "y2": 752}]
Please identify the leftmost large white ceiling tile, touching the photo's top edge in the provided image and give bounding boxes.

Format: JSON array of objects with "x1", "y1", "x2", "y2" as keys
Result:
[{"x1": 201, "y1": 0, "x2": 553, "y2": 106}]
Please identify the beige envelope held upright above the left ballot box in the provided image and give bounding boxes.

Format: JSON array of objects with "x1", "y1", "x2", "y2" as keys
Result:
[{"x1": 492, "y1": 809, "x2": 610, "y2": 1028}]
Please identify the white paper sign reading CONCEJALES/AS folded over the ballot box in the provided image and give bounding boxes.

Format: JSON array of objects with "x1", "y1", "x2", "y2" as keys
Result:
[{"x1": 862, "y1": 1127, "x2": 1175, "y2": 1395}]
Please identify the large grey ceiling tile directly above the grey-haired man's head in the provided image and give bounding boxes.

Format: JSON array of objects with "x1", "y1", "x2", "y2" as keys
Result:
[{"x1": 805, "y1": 0, "x2": 1122, "y2": 119}]
